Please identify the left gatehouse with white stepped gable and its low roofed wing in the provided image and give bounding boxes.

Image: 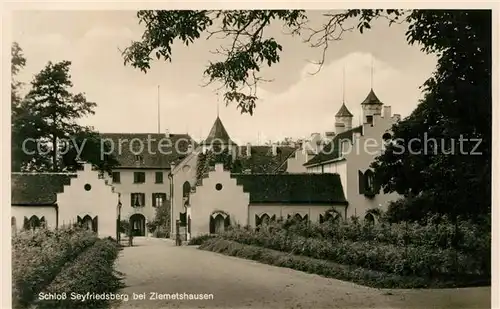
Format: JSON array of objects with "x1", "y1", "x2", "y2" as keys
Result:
[{"x1": 11, "y1": 164, "x2": 121, "y2": 237}]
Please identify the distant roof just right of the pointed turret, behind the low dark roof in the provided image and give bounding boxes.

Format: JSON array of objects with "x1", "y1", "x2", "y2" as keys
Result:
[{"x1": 236, "y1": 146, "x2": 295, "y2": 174}]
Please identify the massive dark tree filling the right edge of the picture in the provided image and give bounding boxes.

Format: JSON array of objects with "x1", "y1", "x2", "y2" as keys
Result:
[{"x1": 373, "y1": 10, "x2": 491, "y2": 220}]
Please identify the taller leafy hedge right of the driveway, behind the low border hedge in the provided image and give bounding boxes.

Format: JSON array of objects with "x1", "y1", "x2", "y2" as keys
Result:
[{"x1": 221, "y1": 228, "x2": 486, "y2": 277}]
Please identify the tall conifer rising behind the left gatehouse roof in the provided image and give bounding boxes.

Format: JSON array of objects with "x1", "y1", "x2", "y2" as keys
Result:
[{"x1": 12, "y1": 61, "x2": 117, "y2": 171}]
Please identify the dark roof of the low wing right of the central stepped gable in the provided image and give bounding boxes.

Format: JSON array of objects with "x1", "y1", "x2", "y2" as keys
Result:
[{"x1": 231, "y1": 174, "x2": 347, "y2": 204}]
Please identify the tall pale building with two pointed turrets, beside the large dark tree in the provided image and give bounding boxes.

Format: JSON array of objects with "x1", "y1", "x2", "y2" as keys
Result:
[{"x1": 304, "y1": 89, "x2": 401, "y2": 220}]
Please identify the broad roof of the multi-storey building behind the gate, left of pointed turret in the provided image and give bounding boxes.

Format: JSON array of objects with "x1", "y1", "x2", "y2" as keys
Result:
[{"x1": 101, "y1": 133, "x2": 196, "y2": 168}]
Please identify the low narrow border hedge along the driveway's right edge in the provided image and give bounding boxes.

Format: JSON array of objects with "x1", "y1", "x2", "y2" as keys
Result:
[{"x1": 199, "y1": 238, "x2": 476, "y2": 288}]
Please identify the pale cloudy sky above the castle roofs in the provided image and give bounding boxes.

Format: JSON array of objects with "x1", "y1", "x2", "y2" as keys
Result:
[{"x1": 12, "y1": 11, "x2": 436, "y2": 143}]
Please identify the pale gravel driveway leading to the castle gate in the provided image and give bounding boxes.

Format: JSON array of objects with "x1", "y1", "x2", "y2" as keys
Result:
[{"x1": 112, "y1": 238, "x2": 490, "y2": 309}]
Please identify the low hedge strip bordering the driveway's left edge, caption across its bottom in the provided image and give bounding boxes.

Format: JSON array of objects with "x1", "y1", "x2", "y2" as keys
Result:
[{"x1": 37, "y1": 239, "x2": 124, "y2": 309}]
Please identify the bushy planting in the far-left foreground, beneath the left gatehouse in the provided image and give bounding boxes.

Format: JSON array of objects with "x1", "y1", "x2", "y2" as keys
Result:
[{"x1": 12, "y1": 228, "x2": 98, "y2": 308}]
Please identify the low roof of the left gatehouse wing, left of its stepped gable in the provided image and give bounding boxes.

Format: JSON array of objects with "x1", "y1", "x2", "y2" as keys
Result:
[{"x1": 11, "y1": 173, "x2": 76, "y2": 206}]
